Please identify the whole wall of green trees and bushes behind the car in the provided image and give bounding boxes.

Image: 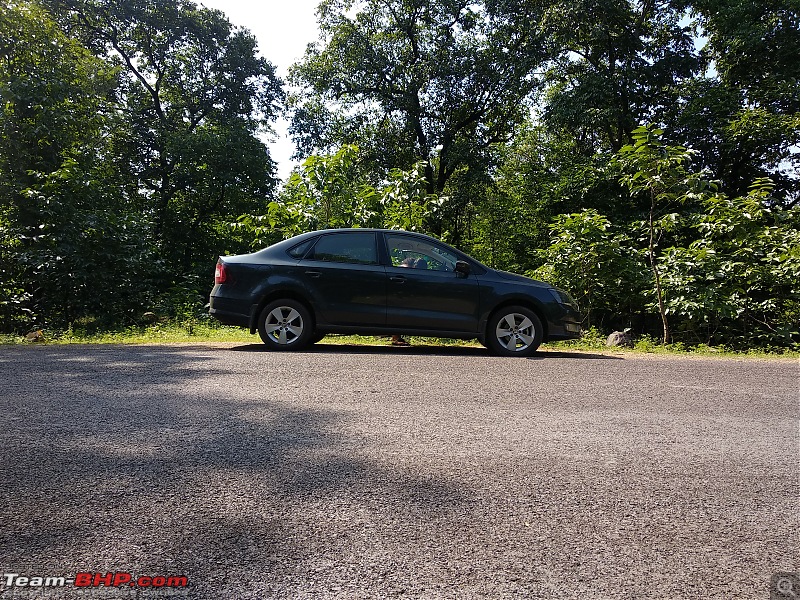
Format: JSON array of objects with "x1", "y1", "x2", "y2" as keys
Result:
[{"x1": 0, "y1": 0, "x2": 800, "y2": 348}]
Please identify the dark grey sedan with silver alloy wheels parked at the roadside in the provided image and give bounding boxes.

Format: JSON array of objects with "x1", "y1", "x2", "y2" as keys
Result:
[{"x1": 209, "y1": 229, "x2": 581, "y2": 356}]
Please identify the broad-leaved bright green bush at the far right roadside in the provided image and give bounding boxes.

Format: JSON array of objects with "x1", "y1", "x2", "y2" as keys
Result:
[{"x1": 664, "y1": 180, "x2": 800, "y2": 346}]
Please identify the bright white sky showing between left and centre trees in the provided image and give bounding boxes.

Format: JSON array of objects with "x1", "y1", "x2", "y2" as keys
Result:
[{"x1": 198, "y1": 0, "x2": 319, "y2": 179}]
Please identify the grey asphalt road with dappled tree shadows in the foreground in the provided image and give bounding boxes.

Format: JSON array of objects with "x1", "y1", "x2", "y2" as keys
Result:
[{"x1": 0, "y1": 343, "x2": 800, "y2": 600}]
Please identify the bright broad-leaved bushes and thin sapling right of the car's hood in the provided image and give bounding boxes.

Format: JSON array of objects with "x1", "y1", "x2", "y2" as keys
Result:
[{"x1": 531, "y1": 128, "x2": 800, "y2": 347}]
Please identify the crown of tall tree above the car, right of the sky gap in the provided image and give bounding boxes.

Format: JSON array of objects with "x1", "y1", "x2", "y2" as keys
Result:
[{"x1": 292, "y1": 0, "x2": 548, "y2": 239}]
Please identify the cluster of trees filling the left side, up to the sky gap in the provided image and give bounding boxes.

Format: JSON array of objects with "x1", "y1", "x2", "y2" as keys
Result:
[{"x1": 0, "y1": 0, "x2": 282, "y2": 327}]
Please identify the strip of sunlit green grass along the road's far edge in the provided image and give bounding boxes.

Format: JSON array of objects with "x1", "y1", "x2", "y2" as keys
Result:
[{"x1": 0, "y1": 322, "x2": 800, "y2": 358}]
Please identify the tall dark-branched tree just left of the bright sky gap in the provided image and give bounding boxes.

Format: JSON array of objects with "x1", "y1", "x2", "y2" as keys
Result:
[{"x1": 53, "y1": 0, "x2": 282, "y2": 274}]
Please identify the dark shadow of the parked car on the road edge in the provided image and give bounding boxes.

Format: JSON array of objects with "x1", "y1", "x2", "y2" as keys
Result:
[{"x1": 228, "y1": 343, "x2": 623, "y2": 360}]
